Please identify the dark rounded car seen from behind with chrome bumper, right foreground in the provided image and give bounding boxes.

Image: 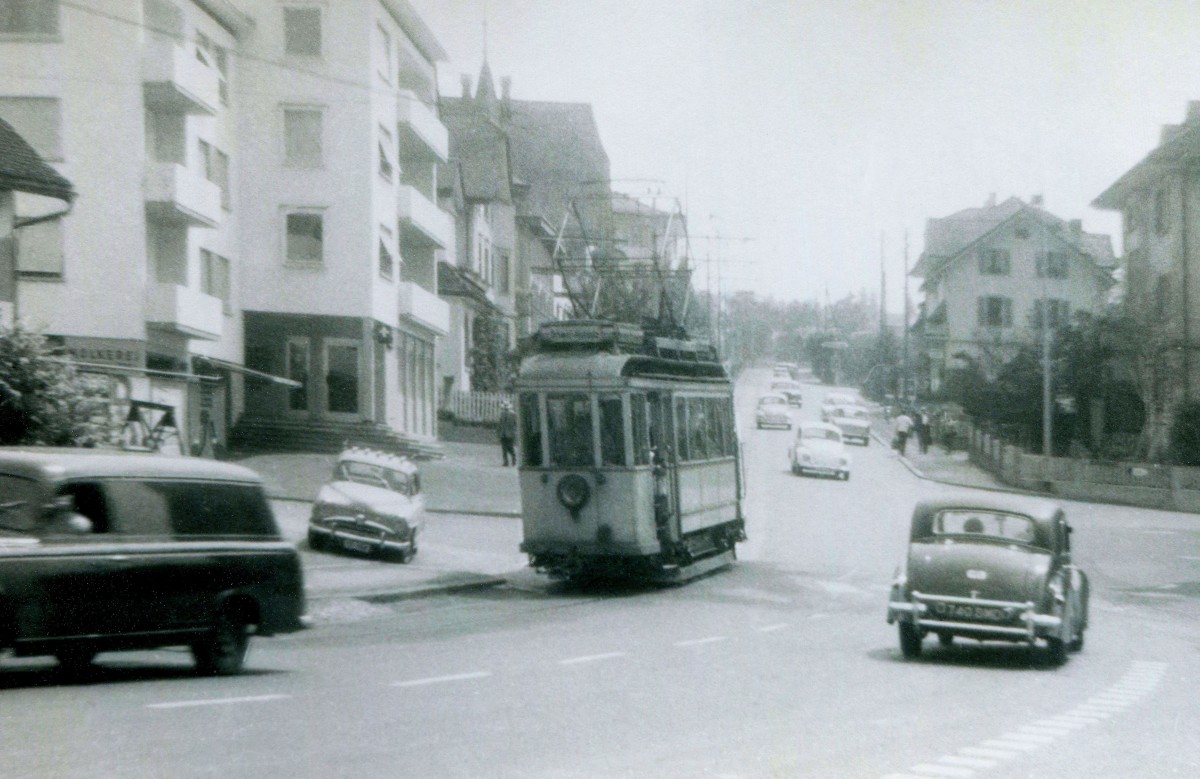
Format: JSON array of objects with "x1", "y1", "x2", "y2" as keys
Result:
[{"x1": 888, "y1": 493, "x2": 1088, "y2": 665}]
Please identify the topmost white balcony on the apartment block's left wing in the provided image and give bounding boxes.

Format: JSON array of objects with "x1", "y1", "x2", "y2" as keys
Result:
[{"x1": 142, "y1": 38, "x2": 221, "y2": 115}]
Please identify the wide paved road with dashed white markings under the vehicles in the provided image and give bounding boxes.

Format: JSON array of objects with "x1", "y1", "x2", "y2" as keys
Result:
[{"x1": 0, "y1": 367, "x2": 1200, "y2": 779}]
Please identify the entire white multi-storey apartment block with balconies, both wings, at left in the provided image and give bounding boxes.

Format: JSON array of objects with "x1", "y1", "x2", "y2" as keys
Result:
[{"x1": 0, "y1": 0, "x2": 454, "y2": 451}]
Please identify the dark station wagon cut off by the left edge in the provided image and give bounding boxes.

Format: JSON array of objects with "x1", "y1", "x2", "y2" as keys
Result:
[{"x1": 0, "y1": 448, "x2": 306, "y2": 673}]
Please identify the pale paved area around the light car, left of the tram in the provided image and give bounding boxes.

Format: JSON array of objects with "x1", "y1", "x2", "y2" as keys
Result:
[{"x1": 231, "y1": 443, "x2": 528, "y2": 602}]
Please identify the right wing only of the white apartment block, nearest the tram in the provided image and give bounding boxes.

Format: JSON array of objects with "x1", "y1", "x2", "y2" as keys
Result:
[{"x1": 239, "y1": 0, "x2": 454, "y2": 441}]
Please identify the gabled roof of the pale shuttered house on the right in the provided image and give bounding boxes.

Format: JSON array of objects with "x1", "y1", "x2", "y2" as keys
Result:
[{"x1": 911, "y1": 197, "x2": 1117, "y2": 278}]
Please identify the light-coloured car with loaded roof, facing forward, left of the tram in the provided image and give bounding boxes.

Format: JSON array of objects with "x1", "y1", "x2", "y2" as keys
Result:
[{"x1": 308, "y1": 448, "x2": 425, "y2": 563}]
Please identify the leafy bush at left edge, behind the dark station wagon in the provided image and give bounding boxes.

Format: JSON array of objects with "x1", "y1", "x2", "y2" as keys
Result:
[{"x1": 0, "y1": 325, "x2": 110, "y2": 447}]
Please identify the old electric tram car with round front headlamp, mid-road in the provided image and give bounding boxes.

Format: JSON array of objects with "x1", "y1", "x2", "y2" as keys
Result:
[{"x1": 516, "y1": 319, "x2": 745, "y2": 581}]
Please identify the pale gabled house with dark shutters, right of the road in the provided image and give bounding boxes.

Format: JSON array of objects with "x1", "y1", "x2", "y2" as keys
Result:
[{"x1": 912, "y1": 197, "x2": 1116, "y2": 394}]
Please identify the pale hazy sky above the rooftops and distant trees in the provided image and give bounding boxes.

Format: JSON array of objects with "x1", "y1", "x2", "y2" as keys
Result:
[{"x1": 409, "y1": 0, "x2": 1200, "y2": 311}]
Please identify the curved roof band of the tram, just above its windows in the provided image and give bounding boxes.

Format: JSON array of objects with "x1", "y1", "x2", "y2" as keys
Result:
[{"x1": 518, "y1": 352, "x2": 730, "y2": 384}]
